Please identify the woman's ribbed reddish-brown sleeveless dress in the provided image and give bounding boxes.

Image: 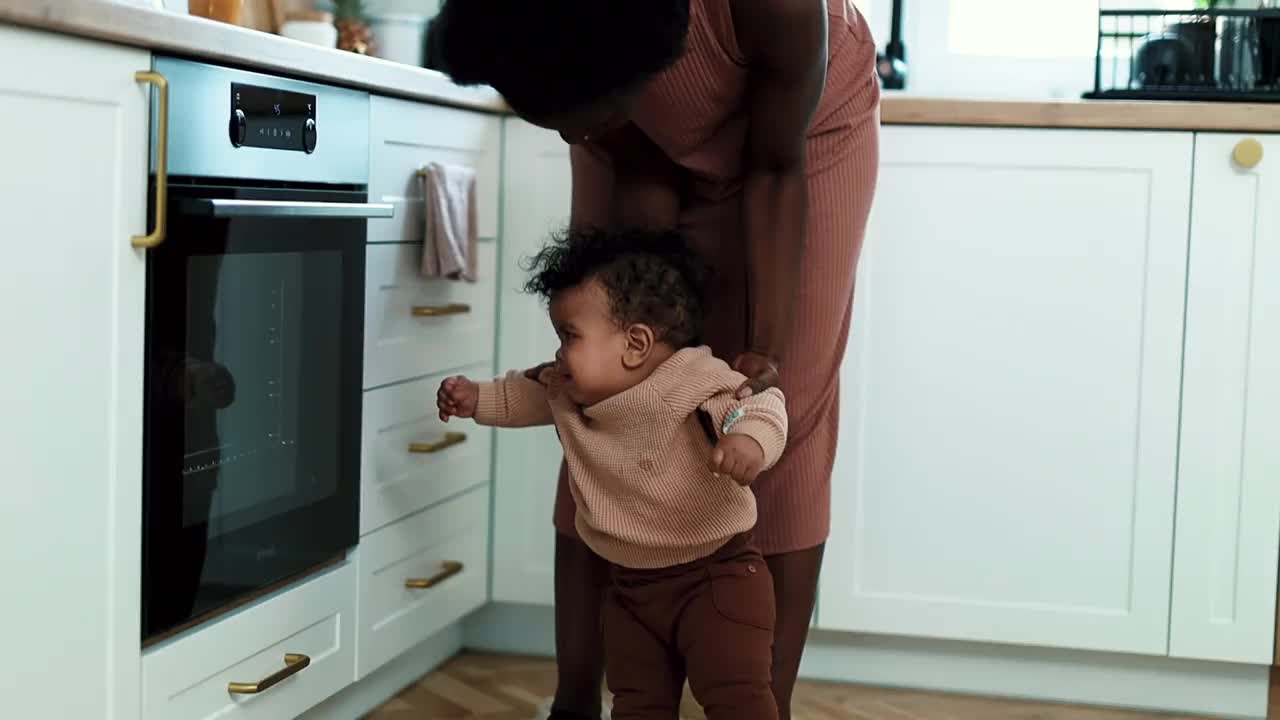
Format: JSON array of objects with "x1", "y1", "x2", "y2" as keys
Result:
[{"x1": 556, "y1": 0, "x2": 881, "y2": 555}]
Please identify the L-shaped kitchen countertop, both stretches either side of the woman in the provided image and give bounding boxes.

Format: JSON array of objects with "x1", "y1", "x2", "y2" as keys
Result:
[{"x1": 0, "y1": 0, "x2": 1280, "y2": 132}]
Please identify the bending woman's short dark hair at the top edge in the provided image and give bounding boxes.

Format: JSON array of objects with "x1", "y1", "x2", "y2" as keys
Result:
[{"x1": 426, "y1": 0, "x2": 690, "y2": 117}]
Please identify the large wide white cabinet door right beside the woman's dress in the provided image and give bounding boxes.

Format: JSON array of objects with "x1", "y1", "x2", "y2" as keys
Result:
[{"x1": 819, "y1": 127, "x2": 1193, "y2": 653}]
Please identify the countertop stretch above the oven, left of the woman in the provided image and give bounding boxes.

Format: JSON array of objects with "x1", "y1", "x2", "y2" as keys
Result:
[{"x1": 0, "y1": 0, "x2": 507, "y2": 113}]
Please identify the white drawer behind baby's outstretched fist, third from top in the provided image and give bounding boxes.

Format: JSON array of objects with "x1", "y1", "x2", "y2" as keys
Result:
[{"x1": 360, "y1": 365, "x2": 493, "y2": 536}]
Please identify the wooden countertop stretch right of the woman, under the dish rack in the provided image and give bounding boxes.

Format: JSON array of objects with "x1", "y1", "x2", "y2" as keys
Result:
[{"x1": 881, "y1": 92, "x2": 1280, "y2": 132}]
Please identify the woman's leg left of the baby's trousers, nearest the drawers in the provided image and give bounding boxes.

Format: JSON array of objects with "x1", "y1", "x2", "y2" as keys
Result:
[{"x1": 552, "y1": 464, "x2": 609, "y2": 720}]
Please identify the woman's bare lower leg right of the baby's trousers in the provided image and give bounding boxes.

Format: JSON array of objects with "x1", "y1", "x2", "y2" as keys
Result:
[{"x1": 764, "y1": 544, "x2": 826, "y2": 720}]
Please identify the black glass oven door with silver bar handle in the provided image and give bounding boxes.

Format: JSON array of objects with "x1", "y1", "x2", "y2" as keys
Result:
[{"x1": 142, "y1": 184, "x2": 392, "y2": 639}]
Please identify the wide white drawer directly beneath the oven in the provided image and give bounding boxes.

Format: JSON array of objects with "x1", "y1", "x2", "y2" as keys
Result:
[{"x1": 142, "y1": 562, "x2": 356, "y2": 720}]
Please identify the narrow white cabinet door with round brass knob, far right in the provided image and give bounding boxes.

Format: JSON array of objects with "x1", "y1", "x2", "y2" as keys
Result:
[{"x1": 1169, "y1": 135, "x2": 1280, "y2": 665}]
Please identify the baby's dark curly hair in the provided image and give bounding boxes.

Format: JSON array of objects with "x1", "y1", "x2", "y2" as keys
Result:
[{"x1": 525, "y1": 228, "x2": 708, "y2": 350}]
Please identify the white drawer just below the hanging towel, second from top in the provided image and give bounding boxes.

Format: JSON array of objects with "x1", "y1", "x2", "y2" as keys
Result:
[{"x1": 365, "y1": 242, "x2": 498, "y2": 388}]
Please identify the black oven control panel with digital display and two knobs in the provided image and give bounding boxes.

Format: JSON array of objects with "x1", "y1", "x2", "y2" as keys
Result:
[{"x1": 229, "y1": 82, "x2": 316, "y2": 154}]
